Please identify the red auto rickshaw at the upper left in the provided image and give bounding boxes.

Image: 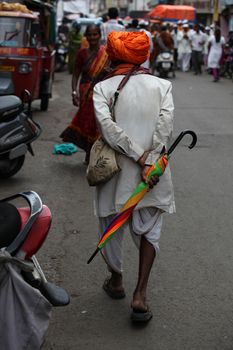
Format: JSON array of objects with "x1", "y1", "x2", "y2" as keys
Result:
[{"x1": 0, "y1": 1, "x2": 55, "y2": 111}]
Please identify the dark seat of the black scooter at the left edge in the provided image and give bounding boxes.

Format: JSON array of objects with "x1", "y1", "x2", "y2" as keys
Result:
[{"x1": 0, "y1": 95, "x2": 23, "y2": 121}]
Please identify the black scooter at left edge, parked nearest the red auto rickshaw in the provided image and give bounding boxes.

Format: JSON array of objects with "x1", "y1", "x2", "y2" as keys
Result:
[{"x1": 0, "y1": 90, "x2": 41, "y2": 179}]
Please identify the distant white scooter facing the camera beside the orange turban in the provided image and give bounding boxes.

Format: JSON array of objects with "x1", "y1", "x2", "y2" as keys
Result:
[{"x1": 155, "y1": 51, "x2": 176, "y2": 78}]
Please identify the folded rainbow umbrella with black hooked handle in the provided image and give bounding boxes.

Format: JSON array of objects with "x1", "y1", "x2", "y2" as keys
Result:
[{"x1": 87, "y1": 130, "x2": 197, "y2": 264}]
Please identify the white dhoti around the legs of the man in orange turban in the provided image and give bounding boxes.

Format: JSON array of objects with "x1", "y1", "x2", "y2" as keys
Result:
[{"x1": 99, "y1": 207, "x2": 164, "y2": 273}]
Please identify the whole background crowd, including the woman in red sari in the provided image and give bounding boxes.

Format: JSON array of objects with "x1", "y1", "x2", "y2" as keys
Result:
[{"x1": 61, "y1": 7, "x2": 232, "y2": 164}]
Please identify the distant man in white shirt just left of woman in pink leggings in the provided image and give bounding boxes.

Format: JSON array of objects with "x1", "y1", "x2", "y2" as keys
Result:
[{"x1": 190, "y1": 24, "x2": 205, "y2": 75}]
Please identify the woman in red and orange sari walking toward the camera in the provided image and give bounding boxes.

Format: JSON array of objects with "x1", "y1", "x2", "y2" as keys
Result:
[{"x1": 60, "y1": 25, "x2": 109, "y2": 163}]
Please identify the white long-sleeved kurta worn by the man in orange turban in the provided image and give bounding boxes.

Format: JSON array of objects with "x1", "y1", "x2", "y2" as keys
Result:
[{"x1": 93, "y1": 74, "x2": 175, "y2": 217}]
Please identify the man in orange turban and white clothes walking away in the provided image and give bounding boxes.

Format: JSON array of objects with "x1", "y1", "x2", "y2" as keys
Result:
[{"x1": 93, "y1": 32, "x2": 175, "y2": 322}]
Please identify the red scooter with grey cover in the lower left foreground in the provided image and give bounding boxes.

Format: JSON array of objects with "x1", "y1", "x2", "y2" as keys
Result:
[{"x1": 0, "y1": 191, "x2": 70, "y2": 350}]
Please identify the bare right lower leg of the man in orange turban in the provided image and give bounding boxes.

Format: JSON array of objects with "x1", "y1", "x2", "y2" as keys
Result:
[{"x1": 131, "y1": 235, "x2": 156, "y2": 311}]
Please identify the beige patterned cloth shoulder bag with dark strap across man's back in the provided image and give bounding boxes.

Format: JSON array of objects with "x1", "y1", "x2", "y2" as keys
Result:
[{"x1": 86, "y1": 67, "x2": 135, "y2": 186}]
